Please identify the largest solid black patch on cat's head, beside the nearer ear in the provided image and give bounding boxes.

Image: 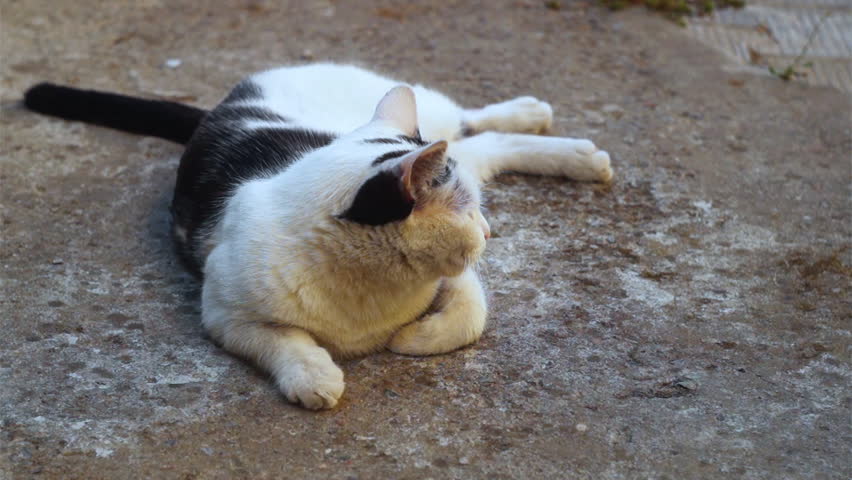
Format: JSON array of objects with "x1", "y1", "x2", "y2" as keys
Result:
[{"x1": 339, "y1": 170, "x2": 414, "y2": 226}]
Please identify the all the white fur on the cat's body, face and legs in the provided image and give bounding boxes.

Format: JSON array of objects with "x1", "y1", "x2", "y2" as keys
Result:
[{"x1": 202, "y1": 64, "x2": 612, "y2": 409}]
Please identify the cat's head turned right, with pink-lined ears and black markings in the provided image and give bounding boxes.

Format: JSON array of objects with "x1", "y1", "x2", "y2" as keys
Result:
[{"x1": 302, "y1": 86, "x2": 490, "y2": 276}]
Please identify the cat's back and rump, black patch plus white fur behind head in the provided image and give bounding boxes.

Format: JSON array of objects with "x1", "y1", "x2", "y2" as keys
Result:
[{"x1": 172, "y1": 63, "x2": 461, "y2": 274}]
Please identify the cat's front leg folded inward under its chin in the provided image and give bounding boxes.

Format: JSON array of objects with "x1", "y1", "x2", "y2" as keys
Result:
[{"x1": 388, "y1": 269, "x2": 486, "y2": 355}]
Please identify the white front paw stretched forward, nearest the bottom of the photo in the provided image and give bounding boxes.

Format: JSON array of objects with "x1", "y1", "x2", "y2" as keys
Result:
[{"x1": 277, "y1": 350, "x2": 344, "y2": 410}]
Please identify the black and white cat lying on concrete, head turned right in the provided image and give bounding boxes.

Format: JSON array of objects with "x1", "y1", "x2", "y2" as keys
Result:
[{"x1": 25, "y1": 63, "x2": 612, "y2": 409}]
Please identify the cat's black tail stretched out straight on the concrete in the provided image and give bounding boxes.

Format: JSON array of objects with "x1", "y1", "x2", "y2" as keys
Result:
[{"x1": 24, "y1": 83, "x2": 207, "y2": 144}]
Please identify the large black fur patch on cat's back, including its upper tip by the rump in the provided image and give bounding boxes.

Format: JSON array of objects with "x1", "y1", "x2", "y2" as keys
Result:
[{"x1": 171, "y1": 78, "x2": 336, "y2": 276}]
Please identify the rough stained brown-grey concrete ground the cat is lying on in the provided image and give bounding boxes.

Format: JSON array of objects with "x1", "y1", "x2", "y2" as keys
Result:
[{"x1": 0, "y1": 0, "x2": 852, "y2": 479}]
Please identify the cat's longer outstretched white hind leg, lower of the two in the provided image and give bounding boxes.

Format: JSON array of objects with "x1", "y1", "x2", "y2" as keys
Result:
[{"x1": 447, "y1": 132, "x2": 612, "y2": 182}]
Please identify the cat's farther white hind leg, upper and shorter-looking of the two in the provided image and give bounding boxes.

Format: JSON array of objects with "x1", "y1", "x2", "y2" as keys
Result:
[{"x1": 462, "y1": 97, "x2": 553, "y2": 135}]
